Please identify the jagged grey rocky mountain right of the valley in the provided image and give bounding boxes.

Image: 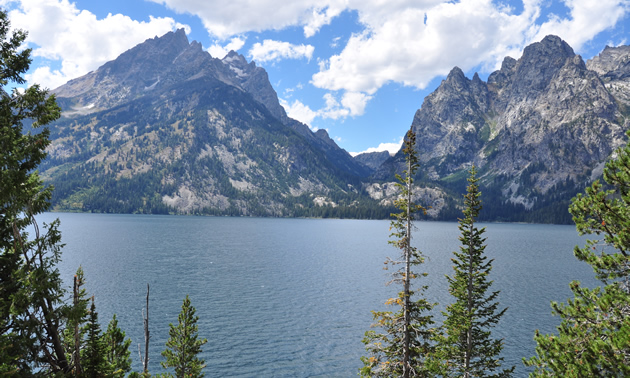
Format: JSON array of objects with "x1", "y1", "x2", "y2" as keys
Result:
[{"x1": 373, "y1": 36, "x2": 630, "y2": 221}]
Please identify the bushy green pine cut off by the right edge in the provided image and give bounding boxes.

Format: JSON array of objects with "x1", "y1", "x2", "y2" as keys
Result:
[{"x1": 525, "y1": 132, "x2": 630, "y2": 377}]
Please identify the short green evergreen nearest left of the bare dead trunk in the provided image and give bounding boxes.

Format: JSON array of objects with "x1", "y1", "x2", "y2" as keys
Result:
[{"x1": 103, "y1": 314, "x2": 131, "y2": 377}]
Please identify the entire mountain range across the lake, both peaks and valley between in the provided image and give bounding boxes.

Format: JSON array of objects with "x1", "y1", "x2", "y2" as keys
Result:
[{"x1": 40, "y1": 30, "x2": 630, "y2": 222}]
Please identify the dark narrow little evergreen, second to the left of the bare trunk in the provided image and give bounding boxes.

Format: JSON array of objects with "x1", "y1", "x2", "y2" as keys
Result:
[{"x1": 81, "y1": 297, "x2": 107, "y2": 378}]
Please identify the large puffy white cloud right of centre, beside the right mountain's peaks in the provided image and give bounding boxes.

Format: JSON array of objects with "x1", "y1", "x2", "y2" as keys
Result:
[{"x1": 312, "y1": 0, "x2": 537, "y2": 94}]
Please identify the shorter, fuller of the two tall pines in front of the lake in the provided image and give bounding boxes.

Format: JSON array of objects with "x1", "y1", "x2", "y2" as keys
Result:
[{"x1": 433, "y1": 165, "x2": 514, "y2": 378}]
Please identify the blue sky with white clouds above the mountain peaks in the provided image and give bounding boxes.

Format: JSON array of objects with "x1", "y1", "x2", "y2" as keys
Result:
[{"x1": 0, "y1": 0, "x2": 630, "y2": 154}]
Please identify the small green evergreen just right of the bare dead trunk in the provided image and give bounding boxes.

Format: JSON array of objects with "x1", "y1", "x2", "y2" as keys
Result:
[{"x1": 162, "y1": 295, "x2": 208, "y2": 378}]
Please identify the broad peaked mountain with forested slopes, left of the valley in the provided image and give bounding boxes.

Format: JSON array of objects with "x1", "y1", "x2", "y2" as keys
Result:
[{"x1": 40, "y1": 30, "x2": 385, "y2": 216}]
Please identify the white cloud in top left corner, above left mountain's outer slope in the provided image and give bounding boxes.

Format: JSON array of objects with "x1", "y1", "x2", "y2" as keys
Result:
[{"x1": 5, "y1": 0, "x2": 183, "y2": 88}]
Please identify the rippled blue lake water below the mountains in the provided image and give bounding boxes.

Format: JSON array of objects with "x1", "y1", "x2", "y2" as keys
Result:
[{"x1": 39, "y1": 213, "x2": 596, "y2": 377}]
